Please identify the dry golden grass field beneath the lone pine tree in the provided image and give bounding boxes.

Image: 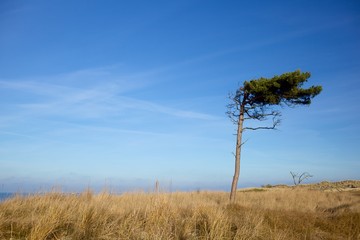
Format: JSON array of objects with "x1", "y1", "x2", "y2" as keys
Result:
[{"x1": 0, "y1": 182, "x2": 360, "y2": 240}]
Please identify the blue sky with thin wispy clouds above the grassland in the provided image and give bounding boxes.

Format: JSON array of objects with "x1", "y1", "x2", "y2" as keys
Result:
[{"x1": 0, "y1": 0, "x2": 360, "y2": 191}]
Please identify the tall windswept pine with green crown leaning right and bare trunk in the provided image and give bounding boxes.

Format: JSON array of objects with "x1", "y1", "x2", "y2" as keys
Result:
[{"x1": 227, "y1": 70, "x2": 322, "y2": 201}]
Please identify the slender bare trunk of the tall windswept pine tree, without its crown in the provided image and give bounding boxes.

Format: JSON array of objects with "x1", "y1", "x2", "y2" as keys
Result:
[{"x1": 230, "y1": 104, "x2": 244, "y2": 202}]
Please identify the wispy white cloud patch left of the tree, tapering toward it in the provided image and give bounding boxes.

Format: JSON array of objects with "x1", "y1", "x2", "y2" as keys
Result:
[{"x1": 0, "y1": 67, "x2": 216, "y2": 124}]
